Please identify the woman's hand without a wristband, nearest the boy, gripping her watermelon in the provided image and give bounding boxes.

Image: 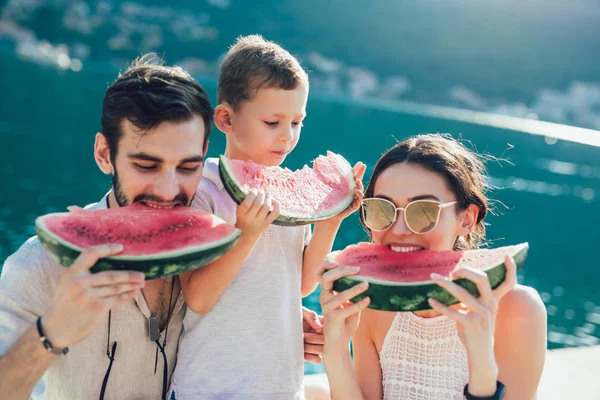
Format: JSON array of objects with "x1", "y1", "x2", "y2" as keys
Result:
[{"x1": 319, "y1": 261, "x2": 370, "y2": 354}]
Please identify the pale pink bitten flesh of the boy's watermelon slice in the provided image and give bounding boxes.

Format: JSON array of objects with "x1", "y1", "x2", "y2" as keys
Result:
[{"x1": 227, "y1": 152, "x2": 355, "y2": 215}]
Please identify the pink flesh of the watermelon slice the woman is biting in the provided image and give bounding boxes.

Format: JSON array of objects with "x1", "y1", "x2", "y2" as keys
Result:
[{"x1": 335, "y1": 243, "x2": 517, "y2": 283}]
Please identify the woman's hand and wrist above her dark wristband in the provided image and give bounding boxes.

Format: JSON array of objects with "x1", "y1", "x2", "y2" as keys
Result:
[{"x1": 429, "y1": 255, "x2": 517, "y2": 396}]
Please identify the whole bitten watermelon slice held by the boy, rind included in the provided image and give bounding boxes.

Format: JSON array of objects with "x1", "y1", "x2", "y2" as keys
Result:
[{"x1": 219, "y1": 152, "x2": 356, "y2": 226}]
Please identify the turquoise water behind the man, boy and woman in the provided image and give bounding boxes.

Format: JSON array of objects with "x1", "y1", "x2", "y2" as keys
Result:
[{"x1": 0, "y1": 57, "x2": 600, "y2": 372}]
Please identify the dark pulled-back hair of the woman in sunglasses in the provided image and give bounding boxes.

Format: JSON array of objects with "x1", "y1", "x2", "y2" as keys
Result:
[{"x1": 360, "y1": 134, "x2": 489, "y2": 250}]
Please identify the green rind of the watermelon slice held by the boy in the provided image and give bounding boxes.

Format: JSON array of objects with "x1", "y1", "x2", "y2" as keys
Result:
[{"x1": 219, "y1": 155, "x2": 355, "y2": 226}]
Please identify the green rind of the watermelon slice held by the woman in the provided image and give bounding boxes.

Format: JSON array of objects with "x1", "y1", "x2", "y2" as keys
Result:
[{"x1": 327, "y1": 243, "x2": 529, "y2": 312}]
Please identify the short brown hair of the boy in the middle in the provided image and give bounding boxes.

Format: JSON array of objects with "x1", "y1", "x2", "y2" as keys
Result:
[{"x1": 217, "y1": 35, "x2": 308, "y2": 110}]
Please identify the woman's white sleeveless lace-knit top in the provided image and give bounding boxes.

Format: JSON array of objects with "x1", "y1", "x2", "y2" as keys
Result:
[{"x1": 380, "y1": 312, "x2": 469, "y2": 400}]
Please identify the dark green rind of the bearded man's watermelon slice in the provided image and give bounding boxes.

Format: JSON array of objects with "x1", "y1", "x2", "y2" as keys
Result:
[{"x1": 35, "y1": 216, "x2": 241, "y2": 280}]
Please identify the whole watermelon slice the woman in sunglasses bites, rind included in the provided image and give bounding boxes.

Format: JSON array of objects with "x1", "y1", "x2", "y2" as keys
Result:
[{"x1": 327, "y1": 243, "x2": 529, "y2": 311}]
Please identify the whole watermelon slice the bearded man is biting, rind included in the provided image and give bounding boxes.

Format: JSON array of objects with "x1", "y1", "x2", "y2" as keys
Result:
[{"x1": 35, "y1": 204, "x2": 241, "y2": 279}]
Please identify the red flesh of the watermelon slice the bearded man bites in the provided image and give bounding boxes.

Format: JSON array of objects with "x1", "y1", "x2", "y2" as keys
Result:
[{"x1": 43, "y1": 204, "x2": 236, "y2": 256}]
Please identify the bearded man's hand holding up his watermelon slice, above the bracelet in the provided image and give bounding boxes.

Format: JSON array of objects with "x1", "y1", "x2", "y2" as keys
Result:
[{"x1": 42, "y1": 244, "x2": 145, "y2": 349}]
